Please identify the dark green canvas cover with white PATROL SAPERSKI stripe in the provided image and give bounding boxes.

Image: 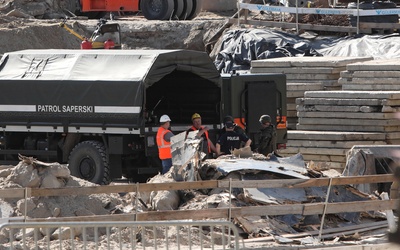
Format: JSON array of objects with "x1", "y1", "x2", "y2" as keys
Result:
[{"x1": 0, "y1": 50, "x2": 221, "y2": 131}]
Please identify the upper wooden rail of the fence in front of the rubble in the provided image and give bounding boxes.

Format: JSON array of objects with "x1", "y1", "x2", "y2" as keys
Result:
[{"x1": 0, "y1": 174, "x2": 394, "y2": 198}]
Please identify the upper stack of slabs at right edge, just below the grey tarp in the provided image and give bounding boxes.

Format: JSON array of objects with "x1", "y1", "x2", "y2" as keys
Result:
[{"x1": 338, "y1": 58, "x2": 400, "y2": 91}]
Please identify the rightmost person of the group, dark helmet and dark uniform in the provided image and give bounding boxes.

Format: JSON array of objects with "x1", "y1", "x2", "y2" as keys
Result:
[{"x1": 257, "y1": 115, "x2": 276, "y2": 156}]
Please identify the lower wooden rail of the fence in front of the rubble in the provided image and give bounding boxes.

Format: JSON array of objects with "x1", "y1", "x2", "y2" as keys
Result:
[{"x1": 27, "y1": 199, "x2": 399, "y2": 222}]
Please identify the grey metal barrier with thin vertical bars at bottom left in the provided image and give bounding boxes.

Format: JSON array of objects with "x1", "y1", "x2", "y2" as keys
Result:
[{"x1": 0, "y1": 221, "x2": 244, "y2": 250}]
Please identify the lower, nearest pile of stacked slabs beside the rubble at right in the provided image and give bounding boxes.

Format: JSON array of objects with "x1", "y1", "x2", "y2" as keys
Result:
[{"x1": 282, "y1": 90, "x2": 400, "y2": 169}]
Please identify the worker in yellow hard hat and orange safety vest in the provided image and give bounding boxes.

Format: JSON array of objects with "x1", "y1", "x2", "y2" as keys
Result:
[{"x1": 186, "y1": 113, "x2": 217, "y2": 159}]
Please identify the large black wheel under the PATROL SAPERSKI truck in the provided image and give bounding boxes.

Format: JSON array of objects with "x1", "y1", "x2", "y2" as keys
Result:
[{"x1": 68, "y1": 141, "x2": 110, "y2": 185}]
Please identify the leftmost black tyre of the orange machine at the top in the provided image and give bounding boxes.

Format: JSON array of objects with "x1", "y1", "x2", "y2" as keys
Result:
[{"x1": 140, "y1": 0, "x2": 174, "y2": 20}]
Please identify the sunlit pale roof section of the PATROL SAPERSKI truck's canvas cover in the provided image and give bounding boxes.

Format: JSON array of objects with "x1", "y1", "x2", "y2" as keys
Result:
[{"x1": 0, "y1": 50, "x2": 220, "y2": 87}]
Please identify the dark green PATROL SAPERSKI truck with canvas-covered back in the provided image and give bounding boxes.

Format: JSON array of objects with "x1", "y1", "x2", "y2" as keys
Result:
[{"x1": 0, "y1": 50, "x2": 286, "y2": 184}]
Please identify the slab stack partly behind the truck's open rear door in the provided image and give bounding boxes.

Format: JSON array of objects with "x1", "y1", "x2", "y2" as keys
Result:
[{"x1": 251, "y1": 57, "x2": 373, "y2": 129}]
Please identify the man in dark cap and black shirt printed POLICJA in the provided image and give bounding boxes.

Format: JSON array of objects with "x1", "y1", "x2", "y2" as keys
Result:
[{"x1": 216, "y1": 121, "x2": 251, "y2": 156}]
